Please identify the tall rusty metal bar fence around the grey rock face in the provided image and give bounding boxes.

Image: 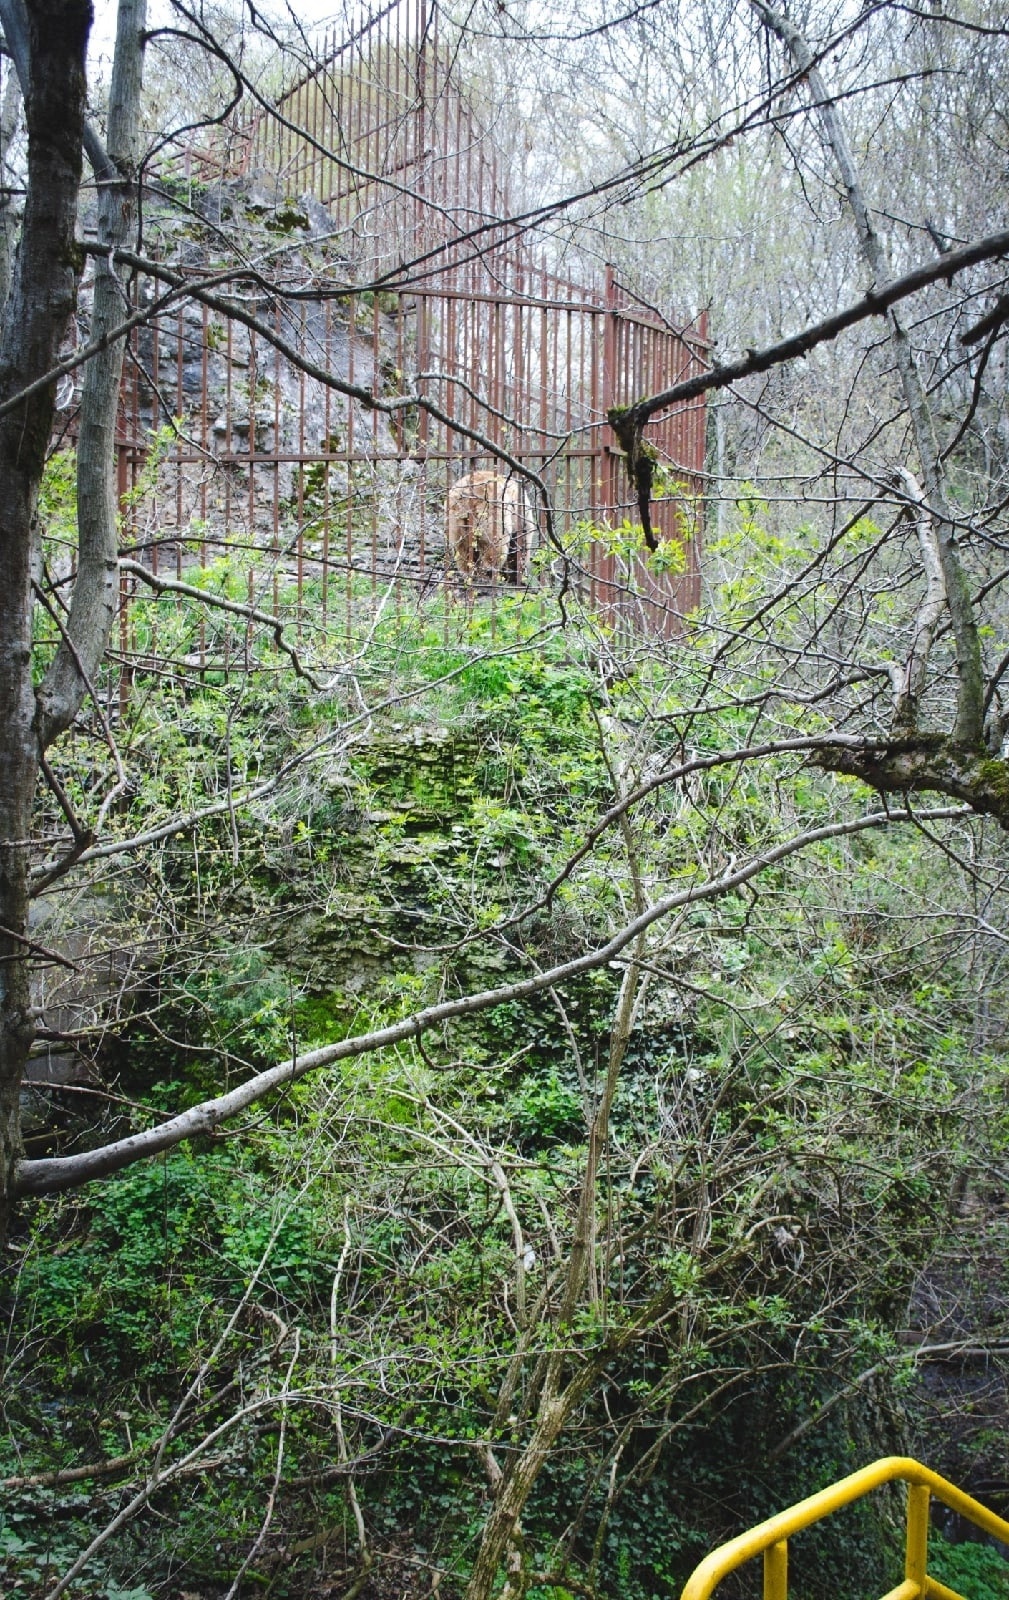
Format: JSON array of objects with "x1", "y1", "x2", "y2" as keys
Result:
[{"x1": 94, "y1": 0, "x2": 707, "y2": 659}]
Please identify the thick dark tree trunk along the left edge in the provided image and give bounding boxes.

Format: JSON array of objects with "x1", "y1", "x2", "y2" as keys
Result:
[{"x1": 0, "y1": 0, "x2": 91, "y2": 1237}]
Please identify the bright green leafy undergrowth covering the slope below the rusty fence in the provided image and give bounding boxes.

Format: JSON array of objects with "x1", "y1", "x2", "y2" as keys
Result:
[{"x1": 7, "y1": 582, "x2": 1004, "y2": 1600}]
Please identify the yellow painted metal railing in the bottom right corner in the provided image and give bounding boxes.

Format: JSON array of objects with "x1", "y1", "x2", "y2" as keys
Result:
[{"x1": 680, "y1": 1456, "x2": 1009, "y2": 1600}]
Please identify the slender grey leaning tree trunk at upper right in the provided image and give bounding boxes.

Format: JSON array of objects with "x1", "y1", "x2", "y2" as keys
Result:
[{"x1": 750, "y1": 0, "x2": 985, "y2": 749}]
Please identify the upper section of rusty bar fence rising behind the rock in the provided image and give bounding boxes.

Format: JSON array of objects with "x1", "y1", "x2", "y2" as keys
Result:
[{"x1": 238, "y1": 0, "x2": 528, "y2": 288}]
